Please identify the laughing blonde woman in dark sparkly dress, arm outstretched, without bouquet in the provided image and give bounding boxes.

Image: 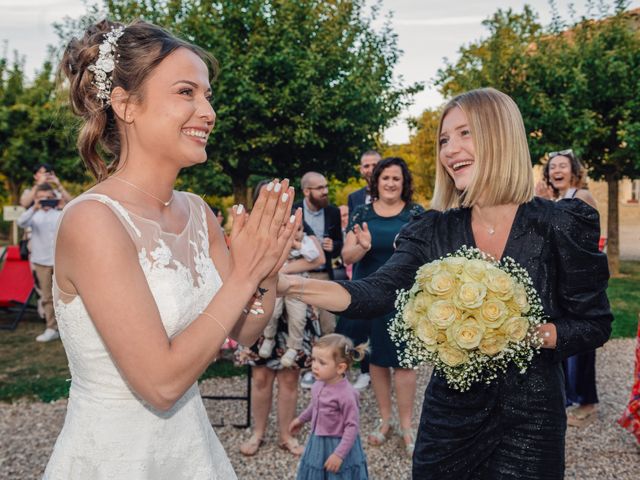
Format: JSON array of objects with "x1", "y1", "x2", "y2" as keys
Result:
[{"x1": 278, "y1": 89, "x2": 612, "y2": 480}]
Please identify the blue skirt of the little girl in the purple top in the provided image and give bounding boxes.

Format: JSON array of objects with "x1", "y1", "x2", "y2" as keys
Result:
[{"x1": 296, "y1": 433, "x2": 369, "y2": 480}]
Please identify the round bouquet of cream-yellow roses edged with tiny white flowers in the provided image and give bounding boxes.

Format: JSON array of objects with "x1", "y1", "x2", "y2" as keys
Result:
[{"x1": 389, "y1": 246, "x2": 545, "y2": 391}]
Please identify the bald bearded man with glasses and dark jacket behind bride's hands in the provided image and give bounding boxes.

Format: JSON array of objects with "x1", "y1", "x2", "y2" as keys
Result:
[{"x1": 294, "y1": 172, "x2": 342, "y2": 388}]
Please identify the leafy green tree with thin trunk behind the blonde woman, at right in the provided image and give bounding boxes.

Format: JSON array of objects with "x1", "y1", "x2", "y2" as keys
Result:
[{"x1": 437, "y1": 0, "x2": 640, "y2": 273}]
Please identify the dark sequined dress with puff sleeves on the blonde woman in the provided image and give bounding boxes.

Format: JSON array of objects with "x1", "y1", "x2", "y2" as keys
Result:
[{"x1": 340, "y1": 198, "x2": 613, "y2": 480}]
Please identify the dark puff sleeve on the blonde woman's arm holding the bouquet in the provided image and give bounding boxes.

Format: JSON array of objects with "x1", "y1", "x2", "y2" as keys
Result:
[{"x1": 551, "y1": 199, "x2": 613, "y2": 360}]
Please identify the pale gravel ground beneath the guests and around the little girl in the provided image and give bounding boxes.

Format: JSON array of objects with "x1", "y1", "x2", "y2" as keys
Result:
[{"x1": 0, "y1": 339, "x2": 640, "y2": 480}]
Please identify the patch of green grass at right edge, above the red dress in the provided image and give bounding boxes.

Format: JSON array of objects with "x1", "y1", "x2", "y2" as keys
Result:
[{"x1": 607, "y1": 262, "x2": 640, "y2": 338}]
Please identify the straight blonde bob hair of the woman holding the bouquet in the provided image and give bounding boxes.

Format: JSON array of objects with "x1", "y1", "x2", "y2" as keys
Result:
[{"x1": 431, "y1": 88, "x2": 533, "y2": 211}]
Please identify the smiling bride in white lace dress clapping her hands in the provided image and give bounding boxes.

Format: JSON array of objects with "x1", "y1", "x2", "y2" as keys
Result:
[{"x1": 44, "y1": 21, "x2": 301, "y2": 480}]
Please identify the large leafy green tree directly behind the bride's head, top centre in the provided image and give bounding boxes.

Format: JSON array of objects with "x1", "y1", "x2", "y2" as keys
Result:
[{"x1": 96, "y1": 0, "x2": 421, "y2": 200}]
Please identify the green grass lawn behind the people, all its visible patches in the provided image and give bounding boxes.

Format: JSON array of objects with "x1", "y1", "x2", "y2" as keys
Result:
[{"x1": 0, "y1": 262, "x2": 640, "y2": 402}]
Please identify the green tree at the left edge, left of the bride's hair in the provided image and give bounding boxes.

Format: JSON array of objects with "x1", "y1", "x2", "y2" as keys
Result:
[{"x1": 0, "y1": 53, "x2": 85, "y2": 204}]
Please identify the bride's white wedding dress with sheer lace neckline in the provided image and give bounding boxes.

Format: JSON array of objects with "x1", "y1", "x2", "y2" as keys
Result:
[{"x1": 44, "y1": 193, "x2": 236, "y2": 480}]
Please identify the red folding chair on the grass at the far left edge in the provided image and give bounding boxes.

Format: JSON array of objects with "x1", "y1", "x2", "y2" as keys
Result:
[{"x1": 0, "y1": 245, "x2": 36, "y2": 330}]
